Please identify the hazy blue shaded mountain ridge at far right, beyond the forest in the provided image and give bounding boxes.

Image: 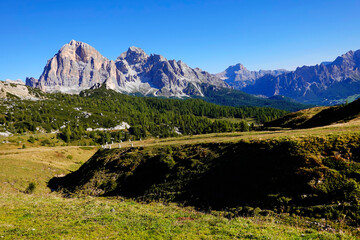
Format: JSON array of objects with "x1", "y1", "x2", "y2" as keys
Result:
[{"x1": 216, "y1": 50, "x2": 360, "y2": 105}]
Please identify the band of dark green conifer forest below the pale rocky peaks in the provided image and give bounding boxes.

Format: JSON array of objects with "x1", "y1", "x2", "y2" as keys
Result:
[{"x1": 0, "y1": 88, "x2": 287, "y2": 144}]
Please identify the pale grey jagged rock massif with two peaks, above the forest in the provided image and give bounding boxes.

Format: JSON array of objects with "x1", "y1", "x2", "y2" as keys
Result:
[{"x1": 26, "y1": 40, "x2": 228, "y2": 97}]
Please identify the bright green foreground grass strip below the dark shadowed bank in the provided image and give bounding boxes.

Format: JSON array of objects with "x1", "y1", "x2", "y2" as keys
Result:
[{"x1": 0, "y1": 194, "x2": 355, "y2": 239}]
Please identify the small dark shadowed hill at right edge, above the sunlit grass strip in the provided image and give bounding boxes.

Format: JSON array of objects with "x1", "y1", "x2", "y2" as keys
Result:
[{"x1": 265, "y1": 99, "x2": 360, "y2": 128}]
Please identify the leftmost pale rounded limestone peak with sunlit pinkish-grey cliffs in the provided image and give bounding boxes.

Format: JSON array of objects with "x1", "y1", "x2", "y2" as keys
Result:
[{"x1": 27, "y1": 40, "x2": 119, "y2": 93}]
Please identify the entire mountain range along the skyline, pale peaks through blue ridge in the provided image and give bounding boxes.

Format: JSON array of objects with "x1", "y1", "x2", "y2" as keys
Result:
[{"x1": 26, "y1": 40, "x2": 360, "y2": 105}]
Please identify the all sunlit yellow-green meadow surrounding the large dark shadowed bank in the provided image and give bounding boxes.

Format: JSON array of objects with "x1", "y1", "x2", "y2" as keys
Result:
[{"x1": 0, "y1": 124, "x2": 360, "y2": 239}]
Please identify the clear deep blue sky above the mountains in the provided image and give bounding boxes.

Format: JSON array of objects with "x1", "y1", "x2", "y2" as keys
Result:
[{"x1": 0, "y1": 0, "x2": 360, "y2": 80}]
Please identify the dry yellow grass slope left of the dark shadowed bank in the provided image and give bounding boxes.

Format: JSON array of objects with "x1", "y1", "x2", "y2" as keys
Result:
[{"x1": 0, "y1": 144, "x2": 97, "y2": 194}]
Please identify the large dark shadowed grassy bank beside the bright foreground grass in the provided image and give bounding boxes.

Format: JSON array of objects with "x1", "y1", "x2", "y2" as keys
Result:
[{"x1": 49, "y1": 133, "x2": 360, "y2": 226}]
